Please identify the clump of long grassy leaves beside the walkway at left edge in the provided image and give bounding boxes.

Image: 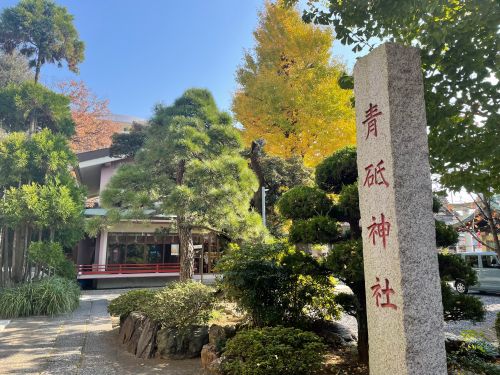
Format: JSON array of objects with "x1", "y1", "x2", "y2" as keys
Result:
[{"x1": 0, "y1": 276, "x2": 80, "y2": 319}]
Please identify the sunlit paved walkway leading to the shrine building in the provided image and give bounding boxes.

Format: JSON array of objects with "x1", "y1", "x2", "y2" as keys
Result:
[{"x1": 0, "y1": 291, "x2": 200, "y2": 375}]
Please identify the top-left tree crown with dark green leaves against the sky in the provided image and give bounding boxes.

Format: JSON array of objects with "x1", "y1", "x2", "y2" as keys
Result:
[{"x1": 0, "y1": 0, "x2": 85, "y2": 82}]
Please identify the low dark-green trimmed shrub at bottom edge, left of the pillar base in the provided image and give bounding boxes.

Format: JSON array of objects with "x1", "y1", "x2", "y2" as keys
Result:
[{"x1": 222, "y1": 327, "x2": 326, "y2": 375}]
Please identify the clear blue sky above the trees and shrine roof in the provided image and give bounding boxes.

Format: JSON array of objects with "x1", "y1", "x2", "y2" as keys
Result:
[{"x1": 0, "y1": 0, "x2": 354, "y2": 118}]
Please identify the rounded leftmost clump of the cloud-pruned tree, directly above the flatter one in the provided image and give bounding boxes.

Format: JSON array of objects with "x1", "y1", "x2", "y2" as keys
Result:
[{"x1": 278, "y1": 186, "x2": 333, "y2": 219}]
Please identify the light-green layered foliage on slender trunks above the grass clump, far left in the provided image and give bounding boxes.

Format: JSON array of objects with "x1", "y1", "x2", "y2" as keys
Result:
[{"x1": 0, "y1": 129, "x2": 84, "y2": 285}]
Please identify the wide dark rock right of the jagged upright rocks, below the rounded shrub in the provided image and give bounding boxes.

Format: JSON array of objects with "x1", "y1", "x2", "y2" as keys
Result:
[{"x1": 156, "y1": 326, "x2": 208, "y2": 359}]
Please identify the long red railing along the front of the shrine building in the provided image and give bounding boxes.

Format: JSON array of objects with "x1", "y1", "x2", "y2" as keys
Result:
[{"x1": 77, "y1": 263, "x2": 180, "y2": 275}]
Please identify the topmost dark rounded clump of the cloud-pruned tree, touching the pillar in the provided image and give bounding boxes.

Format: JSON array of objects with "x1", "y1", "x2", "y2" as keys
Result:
[{"x1": 316, "y1": 146, "x2": 358, "y2": 194}]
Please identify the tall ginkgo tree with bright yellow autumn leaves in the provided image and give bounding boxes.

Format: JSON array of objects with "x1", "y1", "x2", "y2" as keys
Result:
[{"x1": 232, "y1": 2, "x2": 356, "y2": 166}]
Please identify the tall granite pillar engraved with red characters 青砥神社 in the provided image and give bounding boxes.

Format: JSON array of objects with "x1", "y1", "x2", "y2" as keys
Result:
[{"x1": 354, "y1": 43, "x2": 446, "y2": 375}]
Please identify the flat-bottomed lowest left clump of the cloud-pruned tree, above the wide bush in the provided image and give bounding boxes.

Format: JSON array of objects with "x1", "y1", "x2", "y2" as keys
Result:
[{"x1": 289, "y1": 216, "x2": 339, "y2": 244}]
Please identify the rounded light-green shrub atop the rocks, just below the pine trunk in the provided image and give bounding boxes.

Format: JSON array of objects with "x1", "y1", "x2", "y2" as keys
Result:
[{"x1": 143, "y1": 281, "x2": 215, "y2": 329}]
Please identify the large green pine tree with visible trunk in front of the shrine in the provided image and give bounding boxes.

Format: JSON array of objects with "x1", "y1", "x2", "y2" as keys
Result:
[{"x1": 102, "y1": 89, "x2": 262, "y2": 280}]
